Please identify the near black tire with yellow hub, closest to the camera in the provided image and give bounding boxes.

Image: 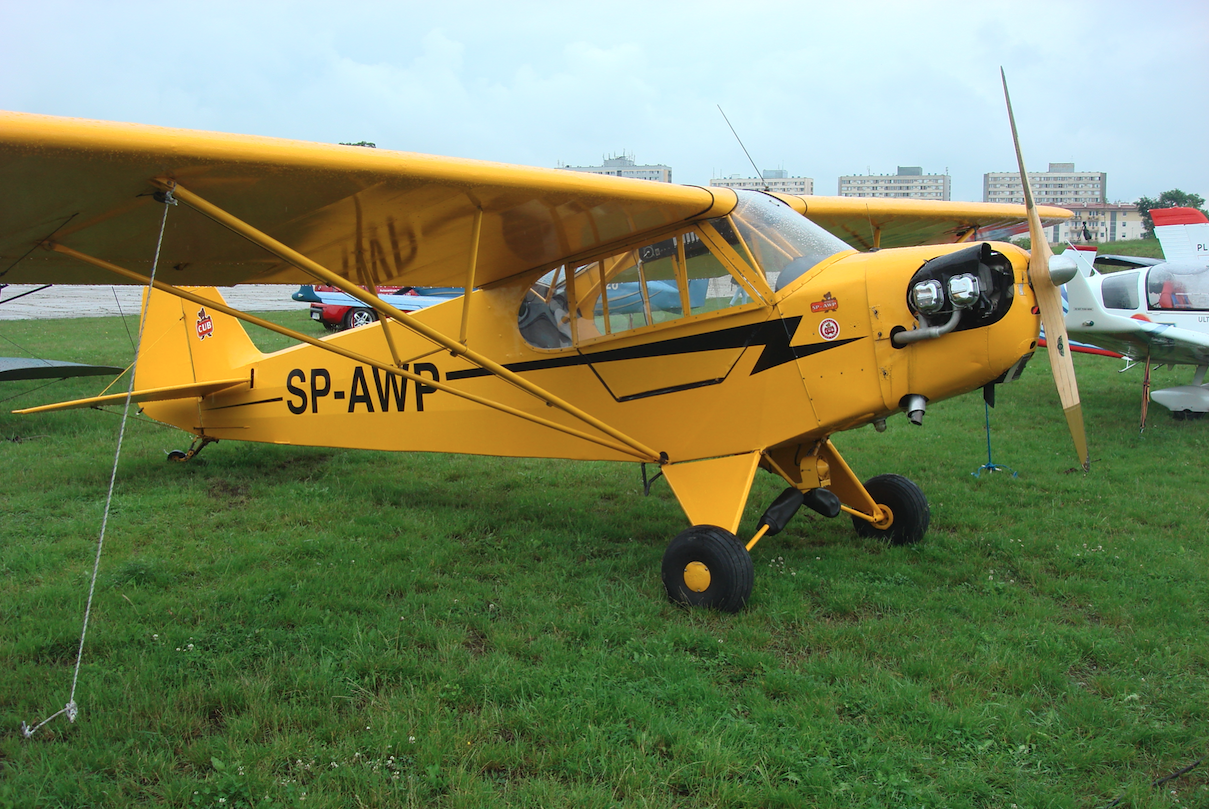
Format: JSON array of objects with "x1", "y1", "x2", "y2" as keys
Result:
[{"x1": 663, "y1": 525, "x2": 756, "y2": 612}]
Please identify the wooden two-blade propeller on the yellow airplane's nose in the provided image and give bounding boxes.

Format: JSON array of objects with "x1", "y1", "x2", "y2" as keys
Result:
[{"x1": 999, "y1": 68, "x2": 1092, "y2": 472}]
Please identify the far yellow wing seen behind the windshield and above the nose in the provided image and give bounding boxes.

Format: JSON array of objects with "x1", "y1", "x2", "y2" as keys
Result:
[{"x1": 775, "y1": 193, "x2": 1071, "y2": 250}]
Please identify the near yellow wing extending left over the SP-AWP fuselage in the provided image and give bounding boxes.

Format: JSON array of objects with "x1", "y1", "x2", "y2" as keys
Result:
[{"x1": 0, "y1": 112, "x2": 735, "y2": 287}]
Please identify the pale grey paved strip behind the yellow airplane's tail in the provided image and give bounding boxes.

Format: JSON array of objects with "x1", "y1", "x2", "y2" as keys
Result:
[{"x1": 0, "y1": 284, "x2": 310, "y2": 320}]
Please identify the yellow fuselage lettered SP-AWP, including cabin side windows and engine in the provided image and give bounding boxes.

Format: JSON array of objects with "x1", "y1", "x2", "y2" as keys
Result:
[{"x1": 139, "y1": 192, "x2": 1039, "y2": 462}]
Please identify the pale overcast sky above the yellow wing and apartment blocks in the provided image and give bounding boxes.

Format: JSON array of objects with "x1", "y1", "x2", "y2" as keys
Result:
[{"x1": 0, "y1": 0, "x2": 1209, "y2": 201}]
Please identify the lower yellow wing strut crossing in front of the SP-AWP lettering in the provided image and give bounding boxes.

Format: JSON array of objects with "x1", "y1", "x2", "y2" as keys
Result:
[{"x1": 42, "y1": 242, "x2": 658, "y2": 461}]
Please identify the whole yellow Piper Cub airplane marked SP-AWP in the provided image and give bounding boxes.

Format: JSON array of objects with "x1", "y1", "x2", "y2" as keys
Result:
[{"x1": 0, "y1": 83, "x2": 1086, "y2": 611}]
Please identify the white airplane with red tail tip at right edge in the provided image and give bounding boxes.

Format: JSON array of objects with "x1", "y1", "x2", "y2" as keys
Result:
[{"x1": 1054, "y1": 208, "x2": 1209, "y2": 427}]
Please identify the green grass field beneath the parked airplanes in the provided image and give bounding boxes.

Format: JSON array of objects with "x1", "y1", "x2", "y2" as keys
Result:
[{"x1": 0, "y1": 313, "x2": 1209, "y2": 809}]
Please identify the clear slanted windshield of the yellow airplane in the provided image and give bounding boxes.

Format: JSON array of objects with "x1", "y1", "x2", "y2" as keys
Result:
[{"x1": 730, "y1": 191, "x2": 852, "y2": 290}]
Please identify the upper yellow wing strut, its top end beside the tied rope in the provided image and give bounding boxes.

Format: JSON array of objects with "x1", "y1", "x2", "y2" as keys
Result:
[{"x1": 152, "y1": 179, "x2": 660, "y2": 461}]
